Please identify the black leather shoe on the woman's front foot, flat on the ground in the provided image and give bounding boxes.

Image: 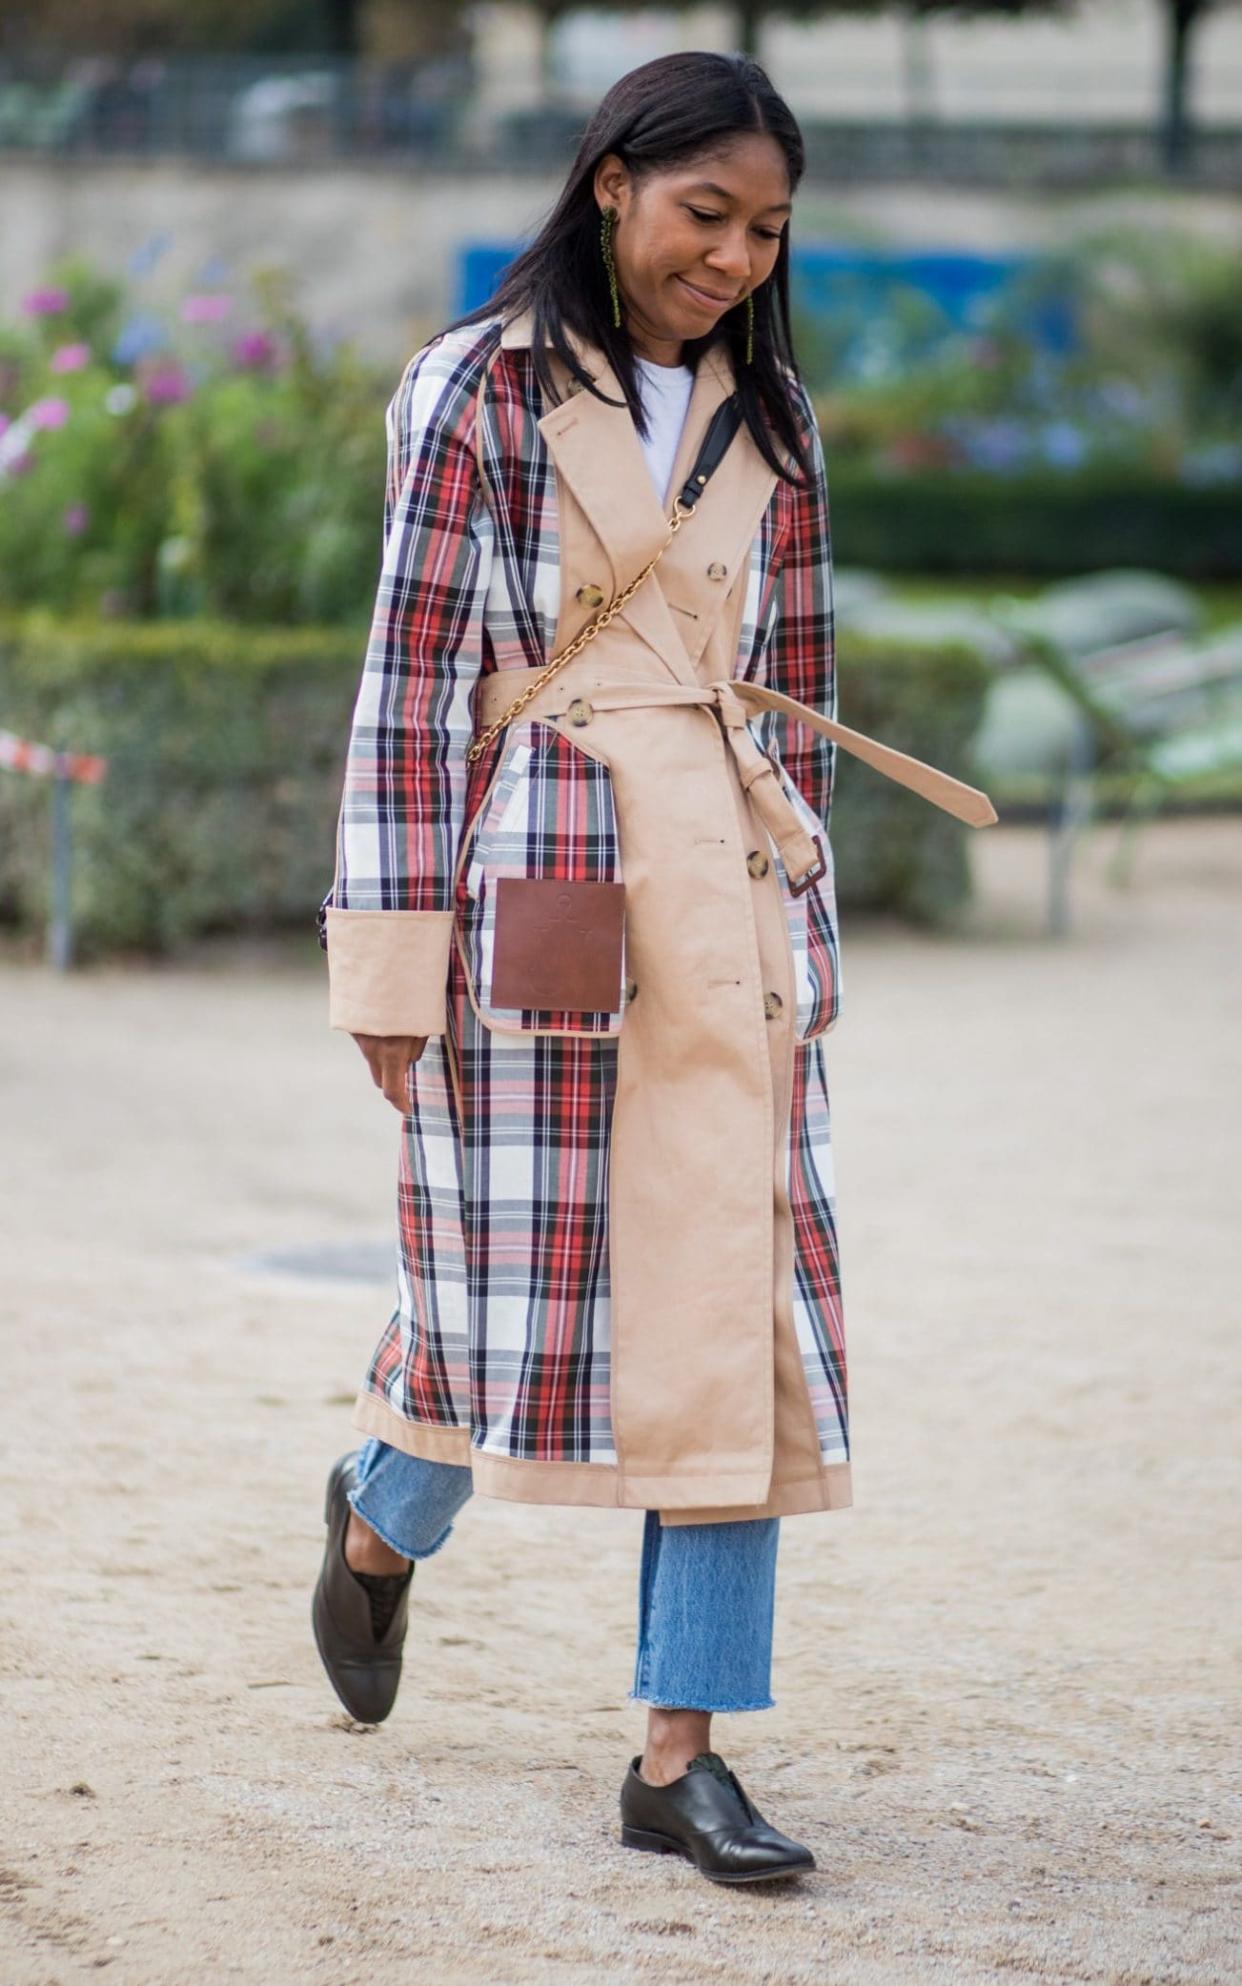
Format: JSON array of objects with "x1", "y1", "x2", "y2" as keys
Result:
[{"x1": 620, "y1": 1752, "x2": 815, "y2": 1883}]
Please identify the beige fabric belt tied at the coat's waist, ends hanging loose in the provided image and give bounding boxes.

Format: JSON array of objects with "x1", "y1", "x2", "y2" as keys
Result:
[{"x1": 475, "y1": 669, "x2": 998, "y2": 886}]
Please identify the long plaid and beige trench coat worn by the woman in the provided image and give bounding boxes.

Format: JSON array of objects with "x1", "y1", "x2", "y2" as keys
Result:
[{"x1": 322, "y1": 316, "x2": 853, "y2": 1523}]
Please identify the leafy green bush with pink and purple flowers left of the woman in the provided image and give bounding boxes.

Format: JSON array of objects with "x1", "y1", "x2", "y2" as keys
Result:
[{"x1": 0, "y1": 264, "x2": 387, "y2": 624}]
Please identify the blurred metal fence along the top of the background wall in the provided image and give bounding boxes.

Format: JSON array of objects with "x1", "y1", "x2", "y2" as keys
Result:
[{"x1": 0, "y1": 56, "x2": 1242, "y2": 189}]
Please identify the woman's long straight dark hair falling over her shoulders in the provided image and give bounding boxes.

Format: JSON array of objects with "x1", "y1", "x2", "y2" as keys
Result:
[{"x1": 449, "y1": 52, "x2": 811, "y2": 483}]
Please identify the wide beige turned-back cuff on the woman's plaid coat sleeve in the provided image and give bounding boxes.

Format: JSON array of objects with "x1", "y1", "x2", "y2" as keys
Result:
[{"x1": 326, "y1": 910, "x2": 453, "y2": 1035}]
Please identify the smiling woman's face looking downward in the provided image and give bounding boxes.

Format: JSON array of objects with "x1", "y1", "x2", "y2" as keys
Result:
[{"x1": 594, "y1": 131, "x2": 791, "y2": 365}]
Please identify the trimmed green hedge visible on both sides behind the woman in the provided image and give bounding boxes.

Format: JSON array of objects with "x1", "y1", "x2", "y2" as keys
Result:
[{"x1": 0, "y1": 616, "x2": 988, "y2": 957}]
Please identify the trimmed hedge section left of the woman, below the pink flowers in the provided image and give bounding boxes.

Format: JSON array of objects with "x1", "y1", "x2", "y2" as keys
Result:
[{"x1": 0, "y1": 616, "x2": 366, "y2": 957}]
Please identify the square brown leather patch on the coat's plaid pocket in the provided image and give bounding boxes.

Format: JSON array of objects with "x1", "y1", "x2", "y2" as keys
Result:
[{"x1": 491, "y1": 876, "x2": 626, "y2": 1013}]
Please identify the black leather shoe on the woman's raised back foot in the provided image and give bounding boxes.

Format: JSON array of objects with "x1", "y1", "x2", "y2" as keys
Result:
[{"x1": 310, "y1": 1452, "x2": 413, "y2": 1724}]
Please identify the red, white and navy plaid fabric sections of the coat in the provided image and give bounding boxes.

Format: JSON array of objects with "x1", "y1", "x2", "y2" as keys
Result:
[{"x1": 332, "y1": 320, "x2": 849, "y2": 1464}]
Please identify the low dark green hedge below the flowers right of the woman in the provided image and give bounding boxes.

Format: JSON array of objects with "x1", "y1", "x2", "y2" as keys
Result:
[{"x1": 829, "y1": 459, "x2": 1242, "y2": 580}]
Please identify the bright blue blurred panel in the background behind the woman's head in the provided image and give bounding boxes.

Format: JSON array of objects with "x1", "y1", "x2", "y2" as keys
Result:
[{"x1": 457, "y1": 242, "x2": 1077, "y2": 377}]
